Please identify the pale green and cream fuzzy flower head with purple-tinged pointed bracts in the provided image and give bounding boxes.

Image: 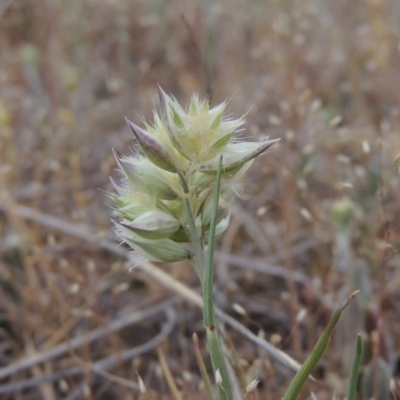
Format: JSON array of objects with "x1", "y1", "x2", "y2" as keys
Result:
[{"x1": 110, "y1": 88, "x2": 277, "y2": 262}]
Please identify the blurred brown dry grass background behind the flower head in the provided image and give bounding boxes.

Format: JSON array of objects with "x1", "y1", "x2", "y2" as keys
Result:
[{"x1": 0, "y1": 0, "x2": 400, "y2": 400}]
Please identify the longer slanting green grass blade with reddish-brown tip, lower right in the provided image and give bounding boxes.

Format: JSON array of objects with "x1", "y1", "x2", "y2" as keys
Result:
[{"x1": 283, "y1": 290, "x2": 359, "y2": 400}]
